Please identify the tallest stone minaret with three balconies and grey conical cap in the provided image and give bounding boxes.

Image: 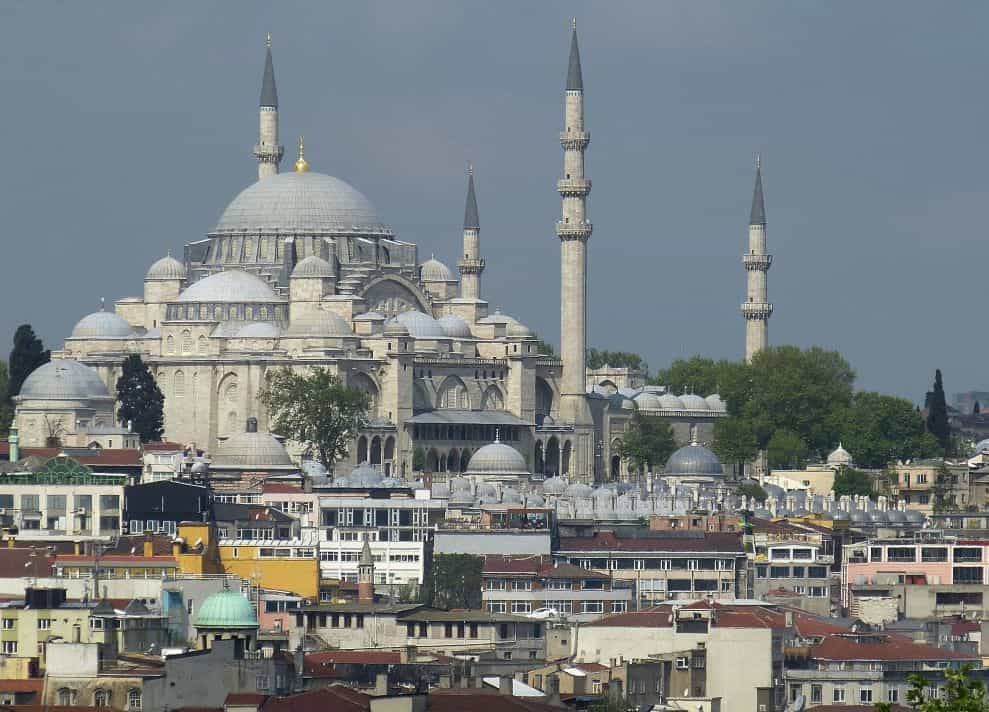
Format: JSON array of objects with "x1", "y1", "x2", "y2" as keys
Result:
[{"x1": 556, "y1": 18, "x2": 591, "y2": 423}]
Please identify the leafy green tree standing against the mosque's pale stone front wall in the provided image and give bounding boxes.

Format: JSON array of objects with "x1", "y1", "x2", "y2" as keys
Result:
[{"x1": 260, "y1": 367, "x2": 370, "y2": 472}]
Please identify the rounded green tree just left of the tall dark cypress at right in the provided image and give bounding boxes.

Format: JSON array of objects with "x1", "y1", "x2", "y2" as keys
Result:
[{"x1": 834, "y1": 391, "x2": 943, "y2": 469}]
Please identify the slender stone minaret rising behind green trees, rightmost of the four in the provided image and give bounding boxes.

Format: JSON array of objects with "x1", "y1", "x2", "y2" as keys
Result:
[{"x1": 742, "y1": 156, "x2": 773, "y2": 361}]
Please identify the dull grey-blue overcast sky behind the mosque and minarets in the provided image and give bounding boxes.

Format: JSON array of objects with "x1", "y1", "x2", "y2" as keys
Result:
[{"x1": 0, "y1": 0, "x2": 989, "y2": 400}]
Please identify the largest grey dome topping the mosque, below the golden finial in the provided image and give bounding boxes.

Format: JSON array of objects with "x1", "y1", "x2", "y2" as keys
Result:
[{"x1": 214, "y1": 172, "x2": 393, "y2": 237}]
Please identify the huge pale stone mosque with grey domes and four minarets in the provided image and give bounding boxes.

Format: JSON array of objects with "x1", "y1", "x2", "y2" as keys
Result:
[{"x1": 16, "y1": 25, "x2": 772, "y2": 482}]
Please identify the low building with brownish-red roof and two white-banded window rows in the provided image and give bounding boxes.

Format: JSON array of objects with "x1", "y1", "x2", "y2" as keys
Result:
[{"x1": 481, "y1": 555, "x2": 633, "y2": 622}]
